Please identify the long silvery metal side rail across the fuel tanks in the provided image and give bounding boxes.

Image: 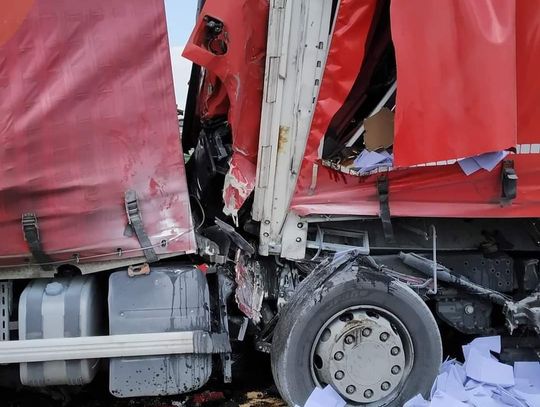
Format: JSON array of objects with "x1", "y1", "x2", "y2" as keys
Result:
[{"x1": 0, "y1": 331, "x2": 231, "y2": 364}]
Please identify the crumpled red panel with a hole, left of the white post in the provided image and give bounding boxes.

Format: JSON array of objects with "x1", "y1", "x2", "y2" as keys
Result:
[{"x1": 183, "y1": 0, "x2": 269, "y2": 216}]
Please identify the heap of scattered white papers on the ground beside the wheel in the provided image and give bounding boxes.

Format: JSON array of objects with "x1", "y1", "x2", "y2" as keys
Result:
[{"x1": 404, "y1": 336, "x2": 540, "y2": 407}]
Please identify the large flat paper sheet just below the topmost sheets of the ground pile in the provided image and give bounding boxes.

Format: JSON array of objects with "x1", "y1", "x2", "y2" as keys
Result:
[{"x1": 465, "y1": 347, "x2": 515, "y2": 387}]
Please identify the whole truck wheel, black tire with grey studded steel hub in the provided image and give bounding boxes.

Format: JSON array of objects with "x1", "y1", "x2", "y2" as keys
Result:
[{"x1": 272, "y1": 266, "x2": 442, "y2": 407}]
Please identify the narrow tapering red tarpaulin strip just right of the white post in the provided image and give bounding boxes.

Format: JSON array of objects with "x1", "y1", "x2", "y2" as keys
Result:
[{"x1": 298, "y1": 0, "x2": 377, "y2": 193}]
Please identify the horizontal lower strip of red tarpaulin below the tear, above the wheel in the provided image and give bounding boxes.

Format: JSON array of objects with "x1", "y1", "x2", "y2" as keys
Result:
[{"x1": 291, "y1": 154, "x2": 540, "y2": 218}]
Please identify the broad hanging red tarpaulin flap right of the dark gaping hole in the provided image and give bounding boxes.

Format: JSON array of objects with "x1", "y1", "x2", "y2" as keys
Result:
[{"x1": 391, "y1": 0, "x2": 519, "y2": 167}]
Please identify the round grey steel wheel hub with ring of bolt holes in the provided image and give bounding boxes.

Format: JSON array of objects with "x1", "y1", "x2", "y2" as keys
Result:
[{"x1": 313, "y1": 309, "x2": 411, "y2": 404}]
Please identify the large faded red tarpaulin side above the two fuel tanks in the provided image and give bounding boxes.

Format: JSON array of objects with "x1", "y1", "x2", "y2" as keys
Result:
[{"x1": 0, "y1": 0, "x2": 195, "y2": 265}]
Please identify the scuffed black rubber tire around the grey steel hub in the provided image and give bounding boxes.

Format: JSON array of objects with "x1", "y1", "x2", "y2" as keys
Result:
[{"x1": 271, "y1": 266, "x2": 442, "y2": 407}]
